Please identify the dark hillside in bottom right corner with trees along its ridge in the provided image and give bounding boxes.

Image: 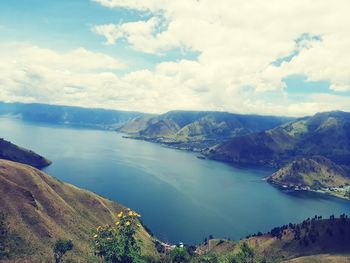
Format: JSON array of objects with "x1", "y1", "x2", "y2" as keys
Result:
[{"x1": 197, "y1": 217, "x2": 350, "y2": 263}]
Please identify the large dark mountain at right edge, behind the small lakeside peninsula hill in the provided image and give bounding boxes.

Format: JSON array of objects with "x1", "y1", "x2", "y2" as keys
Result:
[{"x1": 207, "y1": 111, "x2": 350, "y2": 167}]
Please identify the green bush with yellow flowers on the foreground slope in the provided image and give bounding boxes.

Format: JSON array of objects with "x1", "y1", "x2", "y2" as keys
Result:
[{"x1": 93, "y1": 209, "x2": 146, "y2": 263}]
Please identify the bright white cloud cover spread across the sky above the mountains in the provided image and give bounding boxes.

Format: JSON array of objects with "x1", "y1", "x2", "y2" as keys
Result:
[{"x1": 0, "y1": 0, "x2": 350, "y2": 115}]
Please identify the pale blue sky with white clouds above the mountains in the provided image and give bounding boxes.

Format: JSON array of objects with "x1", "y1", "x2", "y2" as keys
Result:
[{"x1": 0, "y1": 0, "x2": 350, "y2": 116}]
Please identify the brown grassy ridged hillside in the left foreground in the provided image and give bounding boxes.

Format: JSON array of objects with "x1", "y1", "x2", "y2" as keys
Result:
[{"x1": 0, "y1": 160, "x2": 156, "y2": 262}]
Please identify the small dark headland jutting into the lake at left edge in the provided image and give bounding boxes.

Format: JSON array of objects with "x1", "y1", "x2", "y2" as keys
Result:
[{"x1": 0, "y1": 139, "x2": 51, "y2": 168}]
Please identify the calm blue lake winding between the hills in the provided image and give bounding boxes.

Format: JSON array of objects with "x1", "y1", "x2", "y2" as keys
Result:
[{"x1": 0, "y1": 118, "x2": 350, "y2": 244}]
